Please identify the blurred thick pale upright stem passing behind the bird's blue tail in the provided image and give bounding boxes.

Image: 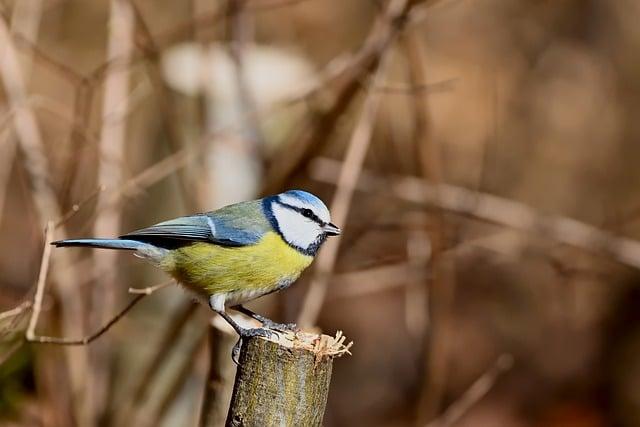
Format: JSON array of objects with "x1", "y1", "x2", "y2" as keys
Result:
[{"x1": 85, "y1": 0, "x2": 138, "y2": 416}]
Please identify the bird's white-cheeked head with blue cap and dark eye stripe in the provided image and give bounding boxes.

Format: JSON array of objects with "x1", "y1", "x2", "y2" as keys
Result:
[{"x1": 264, "y1": 190, "x2": 340, "y2": 256}]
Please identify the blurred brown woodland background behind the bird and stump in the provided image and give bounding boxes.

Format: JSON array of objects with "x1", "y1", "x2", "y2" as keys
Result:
[{"x1": 0, "y1": 0, "x2": 640, "y2": 427}]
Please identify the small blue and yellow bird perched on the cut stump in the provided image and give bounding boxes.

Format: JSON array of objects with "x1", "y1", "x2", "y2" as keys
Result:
[{"x1": 52, "y1": 190, "x2": 341, "y2": 363}]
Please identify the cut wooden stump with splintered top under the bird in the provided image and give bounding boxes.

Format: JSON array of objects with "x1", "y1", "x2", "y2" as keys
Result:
[{"x1": 226, "y1": 333, "x2": 351, "y2": 427}]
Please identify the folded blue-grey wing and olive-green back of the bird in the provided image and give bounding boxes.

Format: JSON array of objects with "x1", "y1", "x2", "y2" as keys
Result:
[{"x1": 121, "y1": 201, "x2": 270, "y2": 246}]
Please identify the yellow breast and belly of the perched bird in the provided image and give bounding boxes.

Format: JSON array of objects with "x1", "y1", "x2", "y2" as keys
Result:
[{"x1": 160, "y1": 232, "x2": 313, "y2": 296}]
